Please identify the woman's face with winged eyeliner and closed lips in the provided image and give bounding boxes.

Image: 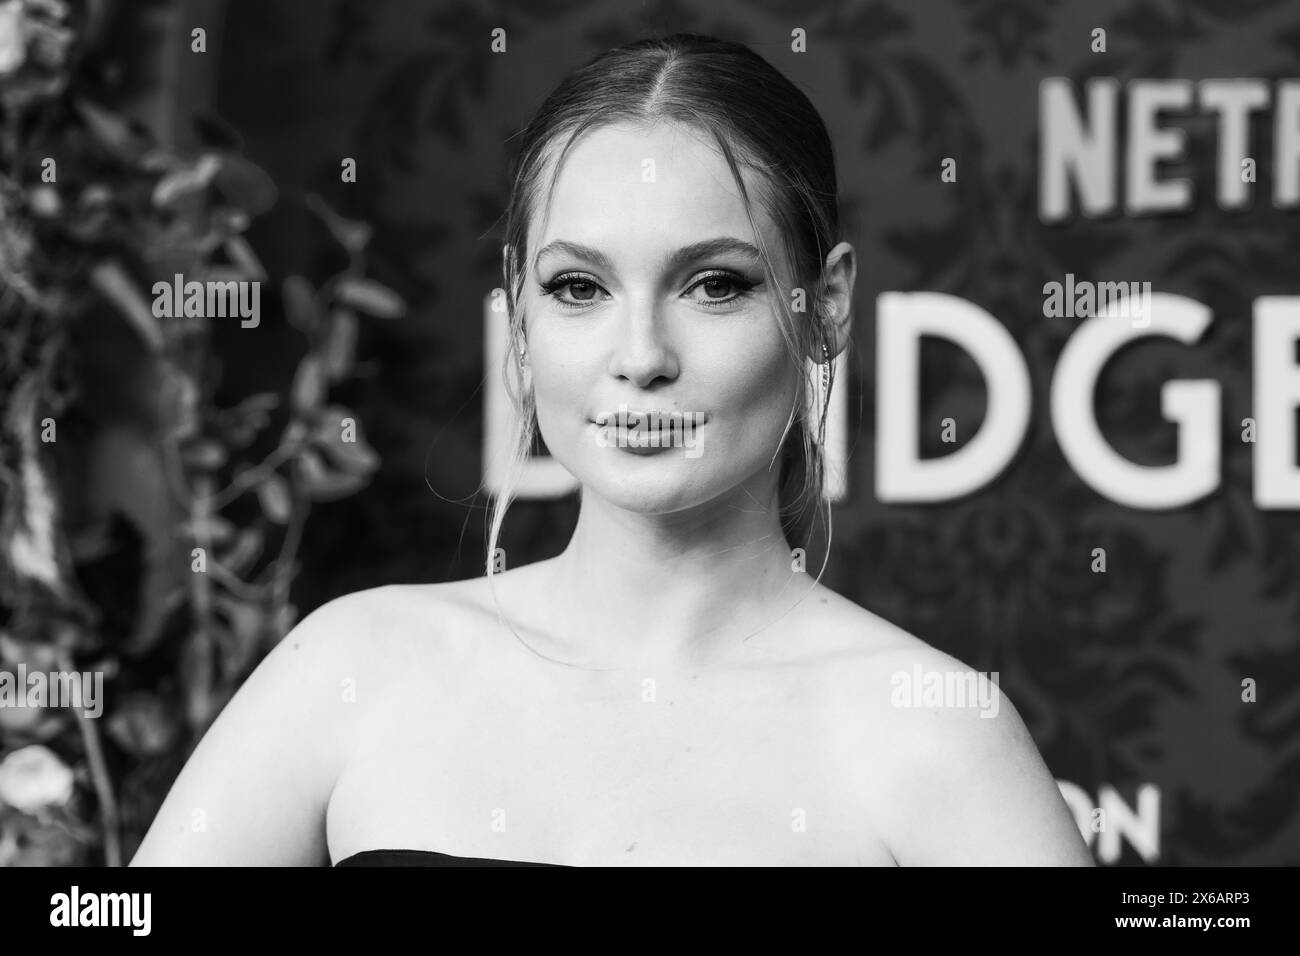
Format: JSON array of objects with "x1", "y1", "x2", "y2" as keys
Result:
[{"x1": 523, "y1": 124, "x2": 802, "y2": 514}]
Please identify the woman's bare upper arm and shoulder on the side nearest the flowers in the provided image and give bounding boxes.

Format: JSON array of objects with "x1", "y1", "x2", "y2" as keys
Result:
[{"x1": 133, "y1": 588, "x2": 441, "y2": 866}]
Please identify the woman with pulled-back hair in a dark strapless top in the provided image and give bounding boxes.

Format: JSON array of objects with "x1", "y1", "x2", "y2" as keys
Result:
[{"x1": 133, "y1": 35, "x2": 1091, "y2": 865}]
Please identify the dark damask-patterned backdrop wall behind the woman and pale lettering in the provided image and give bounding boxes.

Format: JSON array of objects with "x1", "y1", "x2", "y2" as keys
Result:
[{"x1": 216, "y1": 0, "x2": 1300, "y2": 865}]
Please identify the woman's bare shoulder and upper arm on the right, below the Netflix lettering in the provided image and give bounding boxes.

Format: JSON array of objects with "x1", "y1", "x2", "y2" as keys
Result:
[{"x1": 806, "y1": 582, "x2": 1092, "y2": 866}]
